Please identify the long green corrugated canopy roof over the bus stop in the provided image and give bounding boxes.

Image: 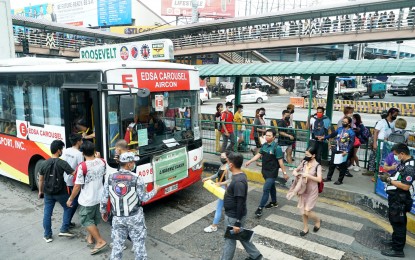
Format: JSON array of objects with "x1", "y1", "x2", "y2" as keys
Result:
[{"x1": 196, "y1": 59, "x2": 415, "y2": 78}]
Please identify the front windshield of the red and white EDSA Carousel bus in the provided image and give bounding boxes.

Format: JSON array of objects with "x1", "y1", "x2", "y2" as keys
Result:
[{"x1": 107, "y1": 90, "x2": 199, "y2": 158}]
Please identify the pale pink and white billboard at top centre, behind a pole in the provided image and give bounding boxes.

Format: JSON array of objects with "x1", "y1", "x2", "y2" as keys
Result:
[{"x1": 161, "y1": 0, "x2": 236, "y2": 18}]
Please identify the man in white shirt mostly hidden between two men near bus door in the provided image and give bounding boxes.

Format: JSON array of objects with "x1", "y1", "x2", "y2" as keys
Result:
[{"x1": 61, "y1": 134, "x2": 84, "y2": 228}]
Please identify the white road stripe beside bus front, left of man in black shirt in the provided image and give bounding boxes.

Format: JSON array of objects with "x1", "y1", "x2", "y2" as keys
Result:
[{"x1": 161, "y1": 186, "x2": 254, "y2": 234}]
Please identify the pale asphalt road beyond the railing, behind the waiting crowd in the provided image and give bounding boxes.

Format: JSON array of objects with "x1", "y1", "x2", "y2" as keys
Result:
[{"x1": 201, "y1": 94, "x2": 415, "y2": 130}]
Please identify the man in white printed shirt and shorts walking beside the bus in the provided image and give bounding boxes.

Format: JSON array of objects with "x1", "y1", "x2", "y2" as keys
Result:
[{"x1": 66, "y1": 141, "x2": 108, "y2": 255}]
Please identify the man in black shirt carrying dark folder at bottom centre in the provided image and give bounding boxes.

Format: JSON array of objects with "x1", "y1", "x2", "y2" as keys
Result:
[{"x1": 220, "y1": 153, "x2": 262, "y2": 260}]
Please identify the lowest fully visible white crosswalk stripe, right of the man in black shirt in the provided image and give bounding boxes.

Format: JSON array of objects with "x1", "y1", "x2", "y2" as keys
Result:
[{"x1": 253, "y1": 225, "x2": 344, "y2": 260}]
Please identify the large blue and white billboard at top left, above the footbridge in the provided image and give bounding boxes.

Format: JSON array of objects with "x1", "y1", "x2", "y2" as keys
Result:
[{"x1": 12, "y1": 0, "x2": 132, "y2": 27}]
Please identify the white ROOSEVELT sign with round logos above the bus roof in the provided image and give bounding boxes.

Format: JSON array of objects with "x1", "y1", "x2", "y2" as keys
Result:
[{"x1": 79, "y1": 39, "x2": 174, "y2": 61}]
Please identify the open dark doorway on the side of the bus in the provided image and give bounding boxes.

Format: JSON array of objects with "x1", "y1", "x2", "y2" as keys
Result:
[{"x1": 63, "y1": 85, "x2": 102, "y2": 154}]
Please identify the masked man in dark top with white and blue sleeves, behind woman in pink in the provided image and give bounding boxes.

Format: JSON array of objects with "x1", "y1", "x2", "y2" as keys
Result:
[{"x1": 306, "y1": 107, "x2": 331, "y2": 164}]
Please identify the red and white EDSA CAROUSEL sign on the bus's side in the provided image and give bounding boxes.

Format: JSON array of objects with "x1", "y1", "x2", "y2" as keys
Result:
[{"x1": 16, "y1": 120, "x2": 65, "y2": 144}]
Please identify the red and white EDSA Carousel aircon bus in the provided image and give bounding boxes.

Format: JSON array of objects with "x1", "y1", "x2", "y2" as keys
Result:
[{"x1": 0, "y1": 58, "x2": 203, "y2": 202}]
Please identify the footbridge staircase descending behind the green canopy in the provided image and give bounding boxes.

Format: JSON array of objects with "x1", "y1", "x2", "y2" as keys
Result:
[{"x1": 219, "y1": 51, "x2": 284, "y2": 89}]
